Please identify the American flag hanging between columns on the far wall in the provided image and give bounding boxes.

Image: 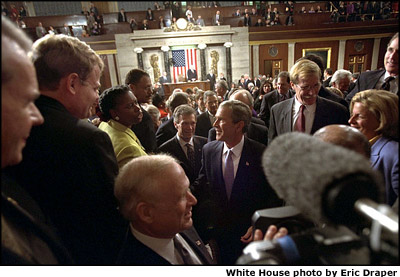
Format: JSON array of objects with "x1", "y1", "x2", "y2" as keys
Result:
[{"x1": 172, "y1": 48, "x2": 197, "y2": 83}]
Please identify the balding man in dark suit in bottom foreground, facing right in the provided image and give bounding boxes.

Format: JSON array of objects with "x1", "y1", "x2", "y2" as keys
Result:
[{"x1": 115, "y1": 155, "x2": 215, "y2": 265}]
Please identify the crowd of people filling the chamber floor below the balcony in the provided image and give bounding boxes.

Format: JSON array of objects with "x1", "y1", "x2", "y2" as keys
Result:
[{"x1": 1, "y1": 9, "x2": 398, "y2": 265}]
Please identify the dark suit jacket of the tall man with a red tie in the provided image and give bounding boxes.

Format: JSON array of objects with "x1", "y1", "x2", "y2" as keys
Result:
[{"x1": 268, "y1": 96, "x2": 350, "y2": 143}]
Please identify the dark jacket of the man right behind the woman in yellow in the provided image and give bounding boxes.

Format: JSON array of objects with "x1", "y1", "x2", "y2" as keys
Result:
[{"x1": 131, "y1": 107, "x2": 157, "y2": 154}]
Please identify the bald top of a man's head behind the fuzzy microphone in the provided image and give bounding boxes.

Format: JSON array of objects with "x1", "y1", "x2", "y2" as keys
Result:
[{"x1": 314, "y1": 124, "x2": 371, "y2": 159}]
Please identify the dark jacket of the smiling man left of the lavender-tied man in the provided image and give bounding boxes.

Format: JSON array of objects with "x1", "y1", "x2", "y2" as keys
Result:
[{"x1": 158, "y1": 136, "x2": 207, "y2": 184}]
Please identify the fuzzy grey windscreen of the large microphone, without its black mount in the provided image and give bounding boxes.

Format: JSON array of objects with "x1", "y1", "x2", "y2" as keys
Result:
[{"x1": 262, "y1": 132, "x2": 381, "y2": 223}]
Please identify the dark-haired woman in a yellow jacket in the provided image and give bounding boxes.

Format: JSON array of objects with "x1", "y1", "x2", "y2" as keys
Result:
[{"x1": 99, "y1": 85, "x2": 147, "y2": 168}]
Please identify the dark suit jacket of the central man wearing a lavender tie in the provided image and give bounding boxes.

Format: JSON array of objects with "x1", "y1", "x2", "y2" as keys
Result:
[{"x1": 193, "y1": 137, "x2": 282, "y2": 264}]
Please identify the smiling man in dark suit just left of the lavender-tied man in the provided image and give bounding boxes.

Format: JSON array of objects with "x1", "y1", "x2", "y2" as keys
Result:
[{"x1": 158, "y1": 105, "x2": 207, "y2": 184}]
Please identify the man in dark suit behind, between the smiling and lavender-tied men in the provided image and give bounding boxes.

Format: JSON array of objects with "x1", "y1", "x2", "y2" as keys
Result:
[{"x1": 195, "y1": 90, "x2": 218, "y2": 138}]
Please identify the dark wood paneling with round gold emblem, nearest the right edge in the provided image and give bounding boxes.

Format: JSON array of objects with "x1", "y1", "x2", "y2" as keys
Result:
[{"x1": 343, "y1": 38, "x2": 374, "y2": 73}]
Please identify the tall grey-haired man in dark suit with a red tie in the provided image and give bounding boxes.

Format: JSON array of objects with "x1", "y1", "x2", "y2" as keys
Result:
[{"x1": 268, "y1": 59, "x2": 349, "y2": 143}]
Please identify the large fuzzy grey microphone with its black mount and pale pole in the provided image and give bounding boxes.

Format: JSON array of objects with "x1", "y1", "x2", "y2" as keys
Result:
[{"x1": 262, "y1": 132, "x2": 398, "y2": 235}]
